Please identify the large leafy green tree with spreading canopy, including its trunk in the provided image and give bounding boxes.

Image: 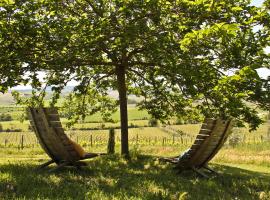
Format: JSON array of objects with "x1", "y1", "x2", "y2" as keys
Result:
[{"x1": 0, "y1": 0, "x2": 269, "y2": 155}]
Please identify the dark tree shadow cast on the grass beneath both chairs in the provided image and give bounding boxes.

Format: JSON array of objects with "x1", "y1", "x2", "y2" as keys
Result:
[{"x1": 0, "y1": 156, "x2": 270, "y2": 199}]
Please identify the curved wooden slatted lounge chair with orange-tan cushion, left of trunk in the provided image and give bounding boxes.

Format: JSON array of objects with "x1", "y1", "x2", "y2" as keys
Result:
[{"x1": 28, "y1": 108, "x2": 103, "y2": 170}]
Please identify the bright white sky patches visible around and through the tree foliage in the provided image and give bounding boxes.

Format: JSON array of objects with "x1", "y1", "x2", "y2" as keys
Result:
[{"x1": 12, "y1": 0, "x2": 270, "y2": 90}]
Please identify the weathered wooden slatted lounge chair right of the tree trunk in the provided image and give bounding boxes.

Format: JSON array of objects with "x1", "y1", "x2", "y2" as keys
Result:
[{"x1": 161, "y1": 119, "x2": 233, "y2": 177}]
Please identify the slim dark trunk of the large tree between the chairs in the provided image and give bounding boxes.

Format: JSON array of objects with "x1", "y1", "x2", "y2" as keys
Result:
[{"x1": 117, "y1": 66, "x2": 129, "y2": 158}]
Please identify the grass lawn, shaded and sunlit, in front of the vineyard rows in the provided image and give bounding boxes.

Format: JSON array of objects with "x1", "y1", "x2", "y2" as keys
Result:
[{"x1": 0, "y1": 146, "x2": 270, "y2": 200}]
